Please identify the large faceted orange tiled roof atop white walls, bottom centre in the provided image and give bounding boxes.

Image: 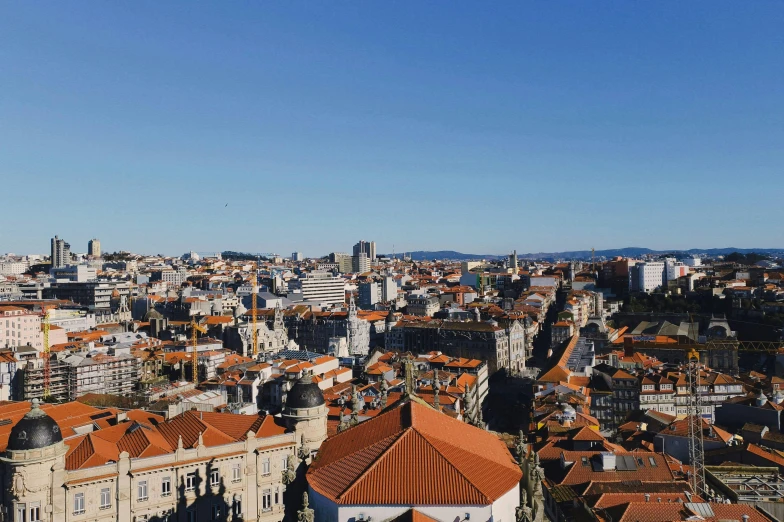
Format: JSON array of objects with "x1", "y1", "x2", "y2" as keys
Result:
[{"x1": 307, "y1": 401, "x2": 522, "y2": 505}]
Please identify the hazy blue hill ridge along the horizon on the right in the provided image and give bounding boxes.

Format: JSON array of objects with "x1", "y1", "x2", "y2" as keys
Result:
[{"x1": 385, "y1": 247, "x2": 784, "y2": 261}]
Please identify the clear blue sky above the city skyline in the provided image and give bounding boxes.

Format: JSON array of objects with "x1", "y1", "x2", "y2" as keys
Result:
[{"x1": 0, "y1": 0, "x2": 784, "y2": 255}]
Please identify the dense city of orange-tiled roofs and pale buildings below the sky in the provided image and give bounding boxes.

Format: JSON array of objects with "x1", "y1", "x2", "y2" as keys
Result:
[{"x1": 0, "y1": 241, "x2": 784, "y2": 521}]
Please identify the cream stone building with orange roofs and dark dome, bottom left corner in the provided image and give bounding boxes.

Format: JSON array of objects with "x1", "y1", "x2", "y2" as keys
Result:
[{"x1": 0, "y1": 401, "x2": 297, "y2": 522}]
